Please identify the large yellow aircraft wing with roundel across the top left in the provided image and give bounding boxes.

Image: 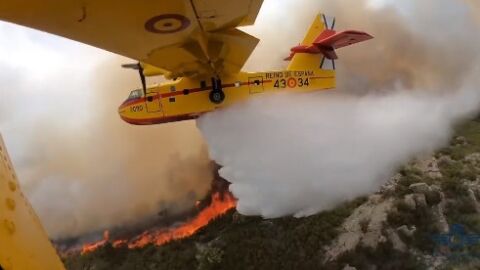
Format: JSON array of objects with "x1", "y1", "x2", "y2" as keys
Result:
[{"x1": 0, "y1": 0, "x2": 263, "y2": 77}]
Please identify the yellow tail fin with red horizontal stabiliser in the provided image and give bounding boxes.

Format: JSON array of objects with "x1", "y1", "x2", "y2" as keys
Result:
[{"x1": 285, "y1": 14, "x2": 373, "y2": 70}]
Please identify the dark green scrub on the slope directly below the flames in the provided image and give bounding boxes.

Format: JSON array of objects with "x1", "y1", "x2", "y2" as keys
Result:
[{"x1": 65, "y1": 198, "x2": 366, "y2": 270}]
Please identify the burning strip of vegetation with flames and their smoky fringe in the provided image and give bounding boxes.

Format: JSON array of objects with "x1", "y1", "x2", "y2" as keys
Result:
[{"x1": 56, "y1": 170, "x2": 236, "y2": 256}]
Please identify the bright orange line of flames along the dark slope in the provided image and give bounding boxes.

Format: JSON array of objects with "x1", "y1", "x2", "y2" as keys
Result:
[{"x1": 82, "y1": 192, "x2": 236, "y2": 254}]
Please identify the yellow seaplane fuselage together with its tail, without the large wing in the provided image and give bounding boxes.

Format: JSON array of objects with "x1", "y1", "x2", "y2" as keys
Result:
[{"x1": 119, "y1": 14, "x2": 372, "y2": 125}]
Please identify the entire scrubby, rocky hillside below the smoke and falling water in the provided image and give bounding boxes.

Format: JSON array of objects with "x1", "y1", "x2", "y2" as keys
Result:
[{"x1": 65, "y1": 121, "x2": 480, "y2": 270}]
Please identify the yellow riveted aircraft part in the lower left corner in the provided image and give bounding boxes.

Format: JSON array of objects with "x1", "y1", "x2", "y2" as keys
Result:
[{"x1": 0, "y1": 135, "x2": 65, "y2": 270}]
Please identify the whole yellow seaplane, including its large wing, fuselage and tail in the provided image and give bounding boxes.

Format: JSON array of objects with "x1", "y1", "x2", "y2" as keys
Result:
[{"x1": 0, "y1": 0, "x2": 372, "y2": 125}]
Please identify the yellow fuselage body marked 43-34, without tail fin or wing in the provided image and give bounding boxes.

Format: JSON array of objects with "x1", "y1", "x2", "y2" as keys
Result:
[{"x1": 119, "y1": 69, "x2": 335, "y2": 125}]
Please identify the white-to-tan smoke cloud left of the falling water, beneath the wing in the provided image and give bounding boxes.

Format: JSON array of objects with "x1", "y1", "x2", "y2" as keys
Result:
[{"x1": 0, "y1": 24, "x2": 213, "y2": 238}]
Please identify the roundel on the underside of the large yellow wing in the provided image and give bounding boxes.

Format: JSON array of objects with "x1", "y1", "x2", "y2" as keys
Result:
[{"x1": 145, "y1": 14, "x2": 190, "y2": 34}]
